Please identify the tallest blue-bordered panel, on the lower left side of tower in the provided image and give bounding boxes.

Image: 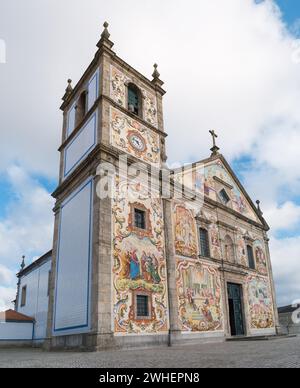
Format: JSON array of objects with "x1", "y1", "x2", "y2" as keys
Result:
[{"x1": 53, "y1": 179, "x2": 93, "y2": 335}]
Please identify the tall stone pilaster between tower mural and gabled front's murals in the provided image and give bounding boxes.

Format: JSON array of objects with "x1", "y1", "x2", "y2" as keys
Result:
[{"x1": 163, "y1": 199, "x2": 181, "y2": 346}]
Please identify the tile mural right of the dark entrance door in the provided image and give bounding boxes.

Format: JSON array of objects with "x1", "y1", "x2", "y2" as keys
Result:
[{"x1": 247, "y1": 276, "x2": 274, "y2": 329}]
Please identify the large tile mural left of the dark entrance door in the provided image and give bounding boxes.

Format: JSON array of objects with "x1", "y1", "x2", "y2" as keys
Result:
[{"x1": 177, "y1": 260, "x2": 223, "y2": 332}]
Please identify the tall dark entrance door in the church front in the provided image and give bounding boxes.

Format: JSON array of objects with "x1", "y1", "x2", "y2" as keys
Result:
[{"x1": 228, "y1": 283, "x2": 245, "y2": 336}]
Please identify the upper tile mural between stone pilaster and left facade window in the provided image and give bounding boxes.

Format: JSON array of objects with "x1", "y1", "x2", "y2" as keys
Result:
[{"x1": 174, "y1": 204, "x2": 198, "y2": 258}]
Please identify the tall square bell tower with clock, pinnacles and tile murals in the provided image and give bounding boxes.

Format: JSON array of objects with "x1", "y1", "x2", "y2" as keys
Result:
[{"x1": 46, "y1": 23, "x2": 169, "y2": 350}]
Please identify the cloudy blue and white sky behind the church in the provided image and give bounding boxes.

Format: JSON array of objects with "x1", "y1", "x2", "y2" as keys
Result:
[{"x1": 0, "y1": 0, "x2": 300, "y2": 311}]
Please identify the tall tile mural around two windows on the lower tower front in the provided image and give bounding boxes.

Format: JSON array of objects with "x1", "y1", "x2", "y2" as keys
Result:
[{"x1": 113, "y1": 178, "x2": 168, "y2": 334}]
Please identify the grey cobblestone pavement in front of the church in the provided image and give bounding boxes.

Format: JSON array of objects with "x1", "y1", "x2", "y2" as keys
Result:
[{"x1": 0, "y1": 337, "x2": 300, "y2": 368}]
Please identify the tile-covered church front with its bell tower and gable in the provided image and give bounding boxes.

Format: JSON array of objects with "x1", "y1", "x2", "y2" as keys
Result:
[{"x1": 39, "y1": 23, "x2": 278, "y2": 350}]
